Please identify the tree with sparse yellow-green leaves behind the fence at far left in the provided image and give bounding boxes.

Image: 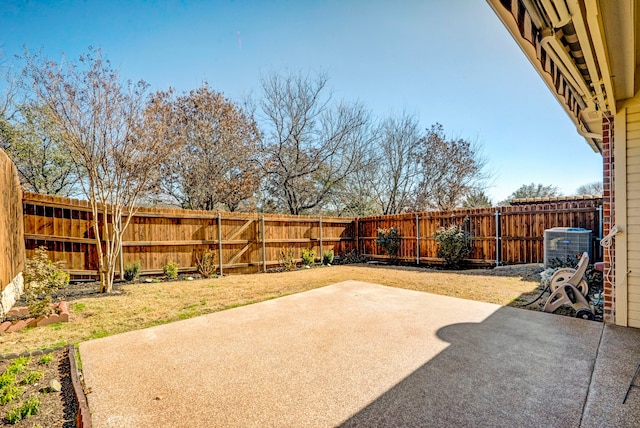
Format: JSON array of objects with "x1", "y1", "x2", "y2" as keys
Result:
[{"x1": 0, "y1": 103, "x2": 77, "y2": 196}]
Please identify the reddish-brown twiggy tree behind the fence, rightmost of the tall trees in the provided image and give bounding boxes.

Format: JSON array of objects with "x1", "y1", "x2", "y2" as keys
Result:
[{"x1": 415, "y1": 123, "x2": 489, "y2": 211}]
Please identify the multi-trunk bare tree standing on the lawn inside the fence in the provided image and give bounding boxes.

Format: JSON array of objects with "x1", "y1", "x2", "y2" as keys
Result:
[{"x1": 23, "y1": 48, "x2": 181, "y2": 292}]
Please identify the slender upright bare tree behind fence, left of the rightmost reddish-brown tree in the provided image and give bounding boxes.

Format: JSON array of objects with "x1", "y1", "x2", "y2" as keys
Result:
[{"x1": 369, "y1": 112, "x2": 422, "y2": 214}]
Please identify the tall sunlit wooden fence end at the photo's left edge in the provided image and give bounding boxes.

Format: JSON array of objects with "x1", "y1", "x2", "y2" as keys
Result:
[{"x1": 0, "y1": 149, "x2": 25, "y2": 291}]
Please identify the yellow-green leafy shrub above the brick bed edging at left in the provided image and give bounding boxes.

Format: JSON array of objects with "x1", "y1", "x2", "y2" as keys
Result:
[{"x1": 23, "y1": 247, "x2": 69, "y2": 316}]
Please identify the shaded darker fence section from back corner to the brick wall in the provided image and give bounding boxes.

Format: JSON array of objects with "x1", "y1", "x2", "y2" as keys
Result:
[{"x1": 357, "y1": 198, "x2": 602, "y2": 266}]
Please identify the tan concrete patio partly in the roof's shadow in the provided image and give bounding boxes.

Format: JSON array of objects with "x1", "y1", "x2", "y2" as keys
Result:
[{"x1": 80, "y1": 281, "x2": 640, "y2": 427}]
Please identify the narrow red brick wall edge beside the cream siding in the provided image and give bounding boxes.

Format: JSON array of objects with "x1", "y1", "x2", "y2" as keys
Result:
[{"x1": 602, "y1": 116, "x2": 616, "y2": 323}]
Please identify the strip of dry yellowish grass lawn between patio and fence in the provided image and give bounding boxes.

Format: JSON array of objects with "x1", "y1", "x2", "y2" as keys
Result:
[{"x1": 0, "y1": 265, "x2": 538, "y2": 354}]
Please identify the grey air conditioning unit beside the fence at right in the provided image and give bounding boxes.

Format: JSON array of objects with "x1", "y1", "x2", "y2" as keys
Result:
[{"x1": 544, "y1": 227, "x2": 593, "y2": 268}]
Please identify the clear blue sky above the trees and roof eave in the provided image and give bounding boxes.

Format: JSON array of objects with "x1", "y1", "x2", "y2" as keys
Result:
[{"x1": 0, "y1": 0, "x2": 602, "y2": 202}]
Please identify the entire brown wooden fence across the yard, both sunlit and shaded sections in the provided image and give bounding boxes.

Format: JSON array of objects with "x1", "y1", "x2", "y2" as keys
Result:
[{"x1": 23, "y1": 192, "x2": 602, "y2": 277}]
